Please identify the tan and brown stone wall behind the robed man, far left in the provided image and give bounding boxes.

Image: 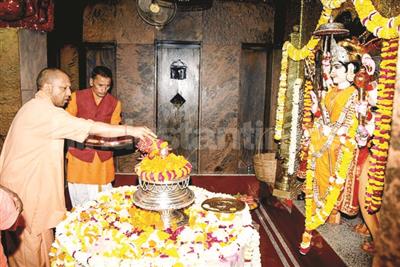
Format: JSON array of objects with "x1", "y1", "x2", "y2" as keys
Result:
[{"x1": 0, "y1": 28, "x2": 47, "y2": 152}]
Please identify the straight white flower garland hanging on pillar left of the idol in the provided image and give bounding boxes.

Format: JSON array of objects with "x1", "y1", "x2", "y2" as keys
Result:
[{"x1": 288, "y1": 78, "x2": 303, "y2": 175}]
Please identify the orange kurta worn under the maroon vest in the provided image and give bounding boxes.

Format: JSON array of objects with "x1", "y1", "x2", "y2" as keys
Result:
[{"x1": 66, "y1": 93, "x2": 121, "y2": 185}]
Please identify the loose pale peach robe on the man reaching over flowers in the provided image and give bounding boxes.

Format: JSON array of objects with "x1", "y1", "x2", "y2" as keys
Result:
[{"x1": 0, "y1": 91, "x2": 95, "y2": 266}]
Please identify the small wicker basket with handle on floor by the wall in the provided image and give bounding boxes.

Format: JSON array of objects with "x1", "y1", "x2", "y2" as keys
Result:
[{"x1": 253, "y1": 134, "x2": 276, "y2": 184}]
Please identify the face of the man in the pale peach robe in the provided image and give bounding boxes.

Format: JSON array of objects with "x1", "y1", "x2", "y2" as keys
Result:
[{"x1": 50, "y1": 73, "x2": 71, "y2": 107}]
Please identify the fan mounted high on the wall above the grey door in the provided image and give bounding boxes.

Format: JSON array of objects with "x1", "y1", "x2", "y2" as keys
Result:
[{"x1": 137, "y1": 0, "x2": 177, "y2": 29}]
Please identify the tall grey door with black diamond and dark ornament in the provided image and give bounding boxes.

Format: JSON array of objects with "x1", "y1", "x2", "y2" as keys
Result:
[{"x1": 156, "y1": 43, "x2": 200, "y2": 172}]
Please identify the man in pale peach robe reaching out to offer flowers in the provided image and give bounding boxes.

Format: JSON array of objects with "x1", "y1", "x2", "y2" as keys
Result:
[{"x1": 0, "y1": 69, "x2": 155, "y2": 267}]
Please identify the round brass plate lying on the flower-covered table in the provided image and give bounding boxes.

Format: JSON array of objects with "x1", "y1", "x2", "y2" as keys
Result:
[{"x1": 201, "y1": 197, "x2": 246, "y2": 213}]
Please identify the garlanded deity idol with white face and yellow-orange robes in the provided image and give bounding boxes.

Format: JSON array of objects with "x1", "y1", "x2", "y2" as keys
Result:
[{"x1": 300, "y1": 40, "x2": 374, "y2": 255}]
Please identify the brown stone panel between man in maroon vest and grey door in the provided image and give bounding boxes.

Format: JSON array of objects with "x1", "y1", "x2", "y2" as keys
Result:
[{"x1": 116, "y1": 43, "x2": 156, "y2": 173}]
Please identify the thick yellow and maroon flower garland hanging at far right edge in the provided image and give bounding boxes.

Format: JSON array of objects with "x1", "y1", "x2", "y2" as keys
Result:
[{"x1": 353, "y1": 0, "x2": 400, "y2": 214}]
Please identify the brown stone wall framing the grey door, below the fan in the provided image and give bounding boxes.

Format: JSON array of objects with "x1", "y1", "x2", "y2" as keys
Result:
[{"x1": 83, "y1": 0, "x2": 274, "y2": 173}]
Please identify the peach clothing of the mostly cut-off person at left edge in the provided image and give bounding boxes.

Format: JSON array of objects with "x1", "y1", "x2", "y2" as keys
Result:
[{"x1": 0, "y1": 188, "x2": 18, "y2": 267}]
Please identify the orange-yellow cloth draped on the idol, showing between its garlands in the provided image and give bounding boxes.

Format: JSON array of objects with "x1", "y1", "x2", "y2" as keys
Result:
[{"x1": 311, "y1": 86, "x2": 358, "y2": 197}]
